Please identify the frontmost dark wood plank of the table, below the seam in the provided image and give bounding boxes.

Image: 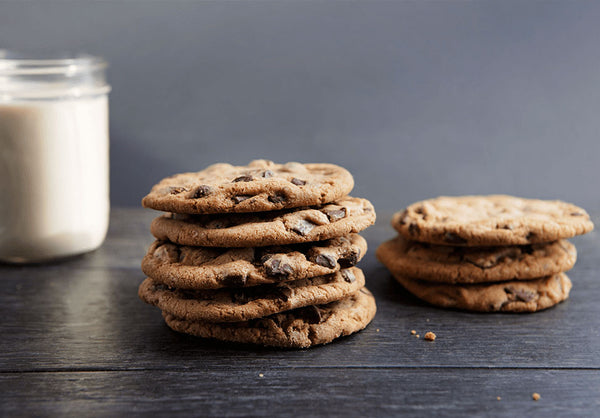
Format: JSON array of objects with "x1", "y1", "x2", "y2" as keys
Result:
[{"x1": 0, "y1": 364, "x2": 600, "y2": 417}]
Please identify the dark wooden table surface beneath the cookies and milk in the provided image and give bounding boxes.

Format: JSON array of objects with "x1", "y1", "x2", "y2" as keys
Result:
[{"x1": 0, "y1": 209, "x2": 600, "y2": 417}]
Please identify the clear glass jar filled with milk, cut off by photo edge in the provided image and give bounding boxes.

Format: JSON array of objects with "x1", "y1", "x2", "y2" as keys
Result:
[{"x1": 0, "y1": 50, "x2": 110, "y2": 263}]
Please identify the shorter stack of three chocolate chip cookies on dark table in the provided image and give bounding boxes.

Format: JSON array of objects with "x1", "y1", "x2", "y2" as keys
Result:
[{"x1": 377, "y1": 195, "x2": 594, "y2": 312}]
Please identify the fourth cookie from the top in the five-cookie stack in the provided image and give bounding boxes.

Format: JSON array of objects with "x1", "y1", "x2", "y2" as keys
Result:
[{"x1": 138, "y1": 267, "x2": 365, "y2": 322}]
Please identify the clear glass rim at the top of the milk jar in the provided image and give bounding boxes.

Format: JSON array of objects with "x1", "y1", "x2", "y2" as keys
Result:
[{"x1": 0, "y1": 49, "x2": 108, "y2": 76}]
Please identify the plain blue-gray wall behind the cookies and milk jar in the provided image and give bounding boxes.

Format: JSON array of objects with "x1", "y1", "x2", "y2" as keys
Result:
[{"x1": 0, "y1": 0, "x2": 600, "y2": 210}]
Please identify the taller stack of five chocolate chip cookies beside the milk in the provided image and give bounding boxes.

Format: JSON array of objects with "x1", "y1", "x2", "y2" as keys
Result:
[{"x1": 138, "y1": 160, "x2": 376, "y2": 348}]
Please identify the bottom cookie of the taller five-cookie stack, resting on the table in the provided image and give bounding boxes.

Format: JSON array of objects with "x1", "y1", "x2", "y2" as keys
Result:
[{"x1": 163, "y1": 287, "x2": 377, "y2": 348}]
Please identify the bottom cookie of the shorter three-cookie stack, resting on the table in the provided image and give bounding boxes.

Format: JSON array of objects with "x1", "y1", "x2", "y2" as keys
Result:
[{"x1": 394, "y1": 273, "x2": 572, "y2": 312}]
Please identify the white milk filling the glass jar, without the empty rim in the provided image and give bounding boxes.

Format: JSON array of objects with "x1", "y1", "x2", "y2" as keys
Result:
[{"x1": 0, "y1": 95, "x2": 109, "y2": 262}]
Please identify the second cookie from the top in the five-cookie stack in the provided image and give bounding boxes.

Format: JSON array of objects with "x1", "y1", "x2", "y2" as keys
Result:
[{"x1": 150, "y1": 196, "x2": 375, "y2": 247}]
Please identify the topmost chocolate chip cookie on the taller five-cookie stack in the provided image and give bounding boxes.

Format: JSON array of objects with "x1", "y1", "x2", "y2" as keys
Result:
[{"x1": 142, "y1": 160, "x2": 354, "y2": 214}]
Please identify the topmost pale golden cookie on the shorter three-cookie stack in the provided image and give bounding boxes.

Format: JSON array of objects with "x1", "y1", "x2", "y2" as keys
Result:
[{"x1": 392, "y1": 195, "x2": 594, "y2": 246}]
